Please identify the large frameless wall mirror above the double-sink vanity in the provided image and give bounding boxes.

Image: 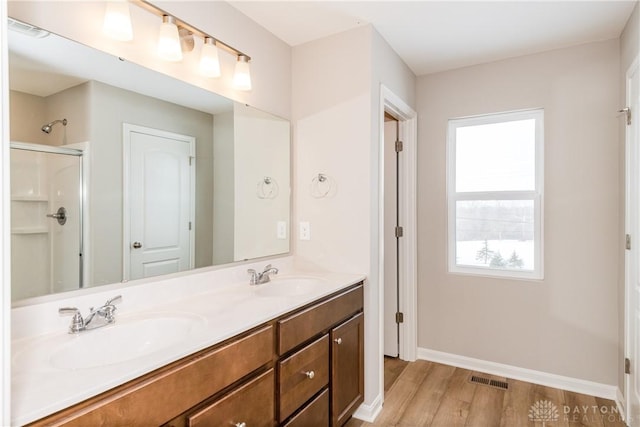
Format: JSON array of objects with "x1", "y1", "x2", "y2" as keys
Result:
[{"x1": 9, "y1": 19, "x2": 290, "y2": 303}]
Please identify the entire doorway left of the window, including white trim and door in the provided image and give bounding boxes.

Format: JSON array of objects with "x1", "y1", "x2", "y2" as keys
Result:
[{"x1": 378, "y1": 86, "x2": 417, "y2": 402}]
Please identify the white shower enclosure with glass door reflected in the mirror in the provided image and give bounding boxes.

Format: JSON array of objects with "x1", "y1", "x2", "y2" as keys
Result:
[{"x1": 10, "y1": 142, "x2": 84, "y2": 301}]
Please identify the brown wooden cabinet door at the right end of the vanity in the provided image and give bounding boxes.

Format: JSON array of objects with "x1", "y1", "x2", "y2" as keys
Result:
[{"x1": 331, "y1": 313, "x2": 364, "y2": 426}]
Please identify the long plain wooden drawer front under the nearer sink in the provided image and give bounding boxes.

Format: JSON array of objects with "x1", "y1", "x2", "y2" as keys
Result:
[{"x1": 28, "y1": 326, "x2": 274, "y2": 427}]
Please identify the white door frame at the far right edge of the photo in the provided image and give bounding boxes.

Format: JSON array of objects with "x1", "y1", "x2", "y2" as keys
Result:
[{"x1": 623, "y1": 57, "x2": 640, "y2": 421}]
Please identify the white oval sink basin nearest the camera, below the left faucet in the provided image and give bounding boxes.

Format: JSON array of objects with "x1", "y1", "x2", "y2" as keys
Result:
[{"x1": 13, "y1": 312, "x2": 206, "y2": 370}]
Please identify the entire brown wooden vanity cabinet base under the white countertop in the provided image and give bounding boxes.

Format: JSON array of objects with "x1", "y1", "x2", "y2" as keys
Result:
[{"x1": 31, "y1": 283, "x2": 364, "y2": 427}]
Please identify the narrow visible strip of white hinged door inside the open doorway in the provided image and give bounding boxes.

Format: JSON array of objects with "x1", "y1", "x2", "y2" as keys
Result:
[{"x1": 384, "y1": 117, "x2": 399, "y2": 357}]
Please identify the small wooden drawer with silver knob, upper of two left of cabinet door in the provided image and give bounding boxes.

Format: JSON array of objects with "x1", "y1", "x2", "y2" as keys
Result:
[{"x1": 278, "y1": 335, "x2": 329, "y2": 422}]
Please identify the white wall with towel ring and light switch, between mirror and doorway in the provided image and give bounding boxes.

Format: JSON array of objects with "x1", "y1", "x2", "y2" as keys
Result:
[{"x1": 292, "y1": 26, "x2": 415, "y2": 418}]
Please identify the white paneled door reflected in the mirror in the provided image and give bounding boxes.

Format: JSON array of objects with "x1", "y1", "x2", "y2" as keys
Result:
[{"x1": 124, "y1": 124, "x2": 195, "y2": 280}]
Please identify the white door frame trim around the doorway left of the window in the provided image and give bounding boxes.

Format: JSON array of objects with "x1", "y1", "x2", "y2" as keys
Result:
[{"x1": 378, "y1": 85, "x2": 418, "y2": 368}]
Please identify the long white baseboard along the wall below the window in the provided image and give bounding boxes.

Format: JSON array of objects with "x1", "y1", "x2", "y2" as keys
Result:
[{"x1": 418, "y1": 348, "x2": 624, "y2": 404}]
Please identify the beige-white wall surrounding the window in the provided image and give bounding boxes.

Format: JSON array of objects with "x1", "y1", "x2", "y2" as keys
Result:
[{"x1": 418, "y1": 40, "x2": 621, "y2": 385}]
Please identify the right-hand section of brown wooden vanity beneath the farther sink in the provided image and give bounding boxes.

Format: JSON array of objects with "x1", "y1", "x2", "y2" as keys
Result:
[{"x1": 277, "y1": 285, "x2": 364, "y2": 427}]
